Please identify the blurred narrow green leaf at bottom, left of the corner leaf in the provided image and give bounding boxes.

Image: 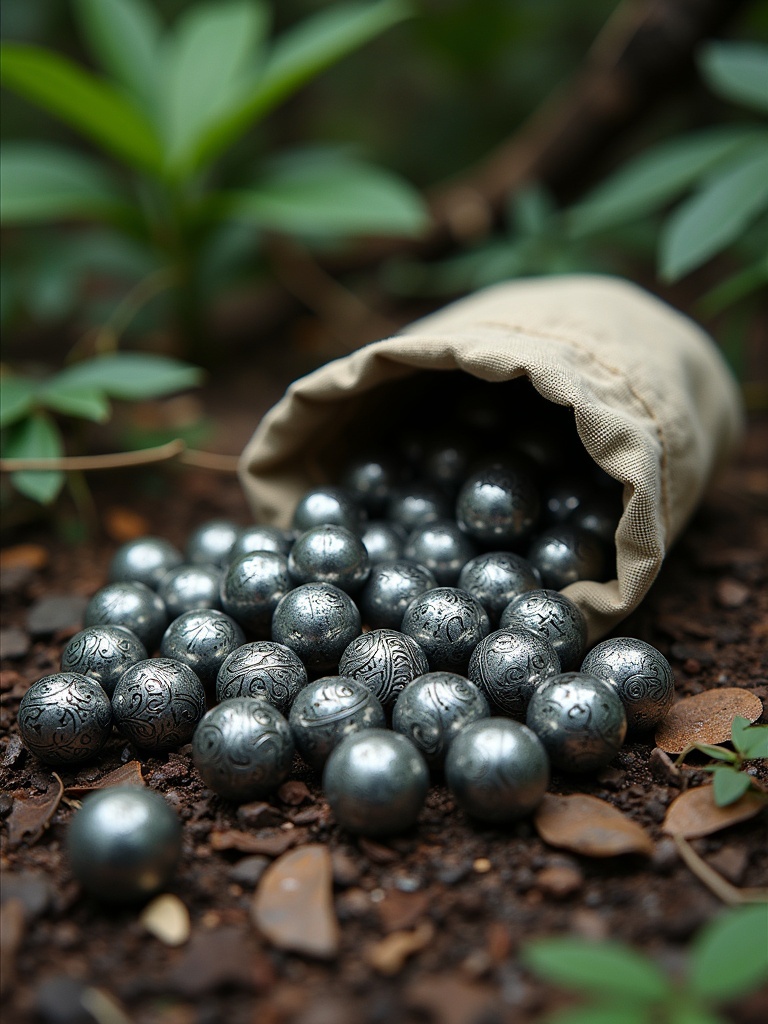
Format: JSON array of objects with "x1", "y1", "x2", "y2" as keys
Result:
[{"x1": 522, "y1": 938, "x2": 671, "y2": 1002}]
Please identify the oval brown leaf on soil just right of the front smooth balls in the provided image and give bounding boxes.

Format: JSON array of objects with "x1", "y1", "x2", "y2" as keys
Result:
[{"x1": 534, "y1": 793, "x2": 653, "y2": 857}]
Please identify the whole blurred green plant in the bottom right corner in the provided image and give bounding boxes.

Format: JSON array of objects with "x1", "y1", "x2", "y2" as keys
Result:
[{"x1": 522, "y1": 903, "x2": 768, "y2": 1024}]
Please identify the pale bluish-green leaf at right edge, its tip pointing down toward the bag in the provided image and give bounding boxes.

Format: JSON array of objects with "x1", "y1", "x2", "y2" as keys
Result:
[{"x1": 659, "y1": 143, "x2": 768, "y2": 281}]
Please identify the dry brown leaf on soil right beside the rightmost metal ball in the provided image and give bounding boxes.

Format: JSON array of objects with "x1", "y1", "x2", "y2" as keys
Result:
[{"x1": 655, "y1": 686, "x2": 763, "y2": 754}]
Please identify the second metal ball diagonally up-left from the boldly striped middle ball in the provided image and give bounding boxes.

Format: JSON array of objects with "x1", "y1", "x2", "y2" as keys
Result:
[{"x1": 220, "y1": 551, "x2": 294, "y2": 639}]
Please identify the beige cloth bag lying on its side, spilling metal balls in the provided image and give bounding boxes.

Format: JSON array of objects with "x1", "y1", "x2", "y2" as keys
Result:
[{"x1": 240, "y1": 275, "x2": 741, "y2": 643}]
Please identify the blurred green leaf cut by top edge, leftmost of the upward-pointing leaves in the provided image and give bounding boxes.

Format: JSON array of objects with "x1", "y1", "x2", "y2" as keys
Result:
[{"x1": 74, "y1": 0, "x2": 163, "y2": 117}]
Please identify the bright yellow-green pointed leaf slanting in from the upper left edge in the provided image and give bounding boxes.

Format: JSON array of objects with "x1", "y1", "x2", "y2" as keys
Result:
[{"x1": 0, "y1": 43, "x2": 161, "y2": 172}]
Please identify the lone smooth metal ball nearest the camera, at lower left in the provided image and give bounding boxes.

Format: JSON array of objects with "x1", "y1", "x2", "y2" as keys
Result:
[{"x1": 67, "y1": 785, "x2": 181, "y2": 903}]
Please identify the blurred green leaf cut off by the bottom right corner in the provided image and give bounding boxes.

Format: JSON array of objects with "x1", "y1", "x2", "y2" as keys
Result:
[{"x1": 689, "y1": 903, "x2": 768, "y2": 1000}]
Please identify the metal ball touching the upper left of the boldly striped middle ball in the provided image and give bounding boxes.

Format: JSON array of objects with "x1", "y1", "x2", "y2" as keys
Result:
[{"x1": 272, "y1": 583, "x2": 360, "y2": 673}]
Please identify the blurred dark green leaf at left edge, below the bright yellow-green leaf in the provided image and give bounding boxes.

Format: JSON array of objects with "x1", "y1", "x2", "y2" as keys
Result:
[{"x1": 0, "y1": 142, "x2": 125, "y2": 224}]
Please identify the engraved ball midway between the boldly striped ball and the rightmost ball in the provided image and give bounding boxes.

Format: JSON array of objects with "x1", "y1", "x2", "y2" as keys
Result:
[{"x1": 467, "y1": 628, "x2": 560, "y2": 718}]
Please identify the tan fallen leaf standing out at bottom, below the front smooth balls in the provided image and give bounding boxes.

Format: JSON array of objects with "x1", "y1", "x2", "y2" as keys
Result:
[{"x1": 253, "y1": 844, "x2": 339, "y2": 959}]
